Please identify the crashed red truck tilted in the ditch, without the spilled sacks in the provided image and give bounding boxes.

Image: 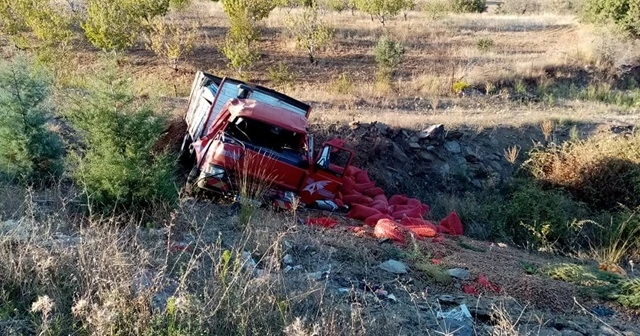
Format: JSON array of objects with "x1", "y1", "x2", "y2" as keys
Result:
[{"x1": 181, "y1": 72, "x2": 353, "y2": 209}]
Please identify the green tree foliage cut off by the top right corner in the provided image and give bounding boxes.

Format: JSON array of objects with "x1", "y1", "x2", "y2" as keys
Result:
[{"x1": 584, "y1": 0, "x2": 640, "y2": 36}]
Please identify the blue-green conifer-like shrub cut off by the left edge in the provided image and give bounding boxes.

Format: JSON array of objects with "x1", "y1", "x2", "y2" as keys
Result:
[{"x1": 0, "y1": 58, "x2": 63, "y2": 181}]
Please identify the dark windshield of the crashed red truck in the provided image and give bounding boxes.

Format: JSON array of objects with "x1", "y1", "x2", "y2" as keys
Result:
[{"x1": 225, "y1": 117, "x2": 303, "y2": 152}]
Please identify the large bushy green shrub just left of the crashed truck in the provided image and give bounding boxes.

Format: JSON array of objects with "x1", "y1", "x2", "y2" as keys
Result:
[{"x1": 67, "y1": 56, "x2": 177, "y2": 209}]
